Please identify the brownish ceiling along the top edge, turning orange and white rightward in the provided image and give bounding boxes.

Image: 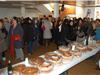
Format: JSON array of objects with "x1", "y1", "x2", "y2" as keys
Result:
[{"x1": 0, "y1": 0, "x2": 98, "y2": 9}]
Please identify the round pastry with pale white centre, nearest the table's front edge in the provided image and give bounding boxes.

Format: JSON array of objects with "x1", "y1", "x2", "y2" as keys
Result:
[{"x1": 38, "y1": 61, "x2": 54, "y2": 73}]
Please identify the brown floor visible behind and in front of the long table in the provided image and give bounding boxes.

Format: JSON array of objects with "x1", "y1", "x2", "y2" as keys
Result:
[{"x1": 6, "y1": 43, "x2": 100, "y2": 75}]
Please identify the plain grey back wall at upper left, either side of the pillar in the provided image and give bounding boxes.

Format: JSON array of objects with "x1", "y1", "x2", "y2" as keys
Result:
[{"x1": 0, "y1": 8, "x2": 40, "y2": 18}]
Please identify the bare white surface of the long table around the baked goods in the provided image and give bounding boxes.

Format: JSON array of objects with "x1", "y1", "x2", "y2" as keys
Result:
[{"x1": 0, "y1": 46, "x2": 100, "y2": 75}]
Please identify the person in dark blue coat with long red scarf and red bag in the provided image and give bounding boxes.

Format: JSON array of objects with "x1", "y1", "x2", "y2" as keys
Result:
[{"x1": 10, "y1": 17, "x2": 24, "y2": 60}]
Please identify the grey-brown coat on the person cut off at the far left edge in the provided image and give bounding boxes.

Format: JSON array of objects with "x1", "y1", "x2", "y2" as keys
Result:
[{"x1": 0, "y1": 30, "x2": 8, "y2": 53}]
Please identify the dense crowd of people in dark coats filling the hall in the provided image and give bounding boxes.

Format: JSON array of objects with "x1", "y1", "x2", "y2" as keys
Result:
[{"x1": 0, "y1": 15, "x2": 100, "y2": 67}]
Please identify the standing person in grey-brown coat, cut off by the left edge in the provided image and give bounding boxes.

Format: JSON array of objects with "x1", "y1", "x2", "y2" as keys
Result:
[{"x1": 0, "y1": 19, "x2": 8, "y2": 67}]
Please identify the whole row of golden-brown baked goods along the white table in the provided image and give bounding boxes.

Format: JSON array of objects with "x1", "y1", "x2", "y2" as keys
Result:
[{"x1": 13, "y1": 42, "x2": 96, "y2": 75}]
